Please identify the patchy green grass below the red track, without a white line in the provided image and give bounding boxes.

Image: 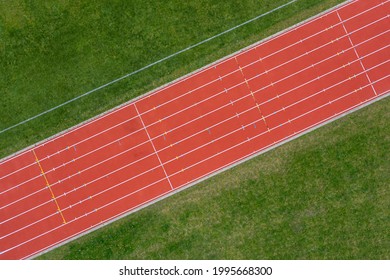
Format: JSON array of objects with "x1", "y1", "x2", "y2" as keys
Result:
[{"x1": 39, "y1": 98, "x2": 390, "y2": 259}]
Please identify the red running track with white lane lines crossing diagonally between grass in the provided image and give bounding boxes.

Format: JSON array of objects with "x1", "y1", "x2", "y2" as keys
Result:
[{"x1": 0, "y1": 0, "x2": 390, "y2": 259}]
